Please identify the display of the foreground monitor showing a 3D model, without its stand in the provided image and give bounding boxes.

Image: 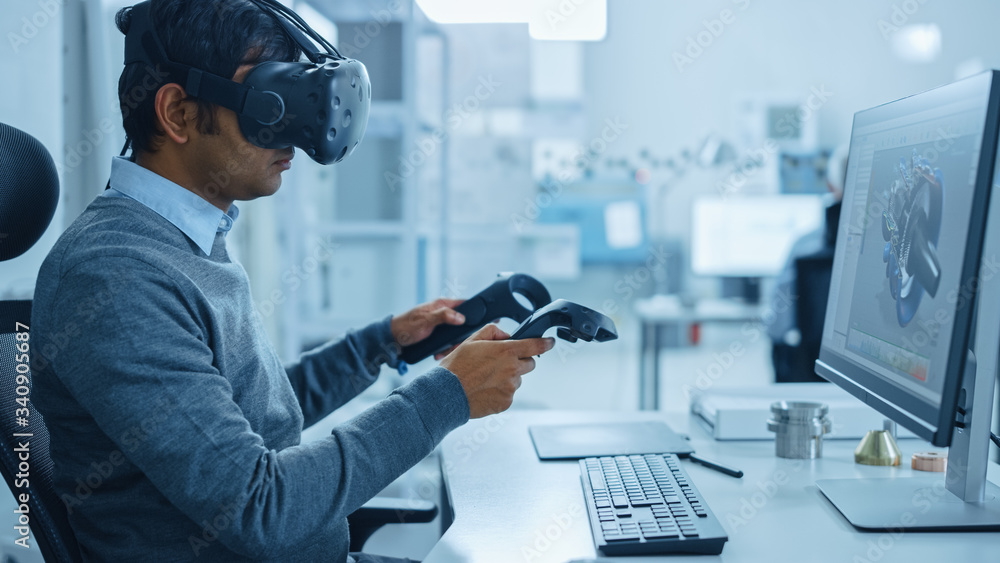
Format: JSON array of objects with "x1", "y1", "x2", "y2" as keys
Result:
[{"x1": 820, "y1": 70, "x2": 996, "y2": 437}]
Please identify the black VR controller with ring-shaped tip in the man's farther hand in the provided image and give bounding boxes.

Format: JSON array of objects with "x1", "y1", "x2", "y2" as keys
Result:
[{"x1": 399, "y1": 274, "x2": 552, "y2": 364}]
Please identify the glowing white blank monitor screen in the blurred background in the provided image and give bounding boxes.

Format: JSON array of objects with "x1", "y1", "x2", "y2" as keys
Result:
[{"x1": 691, "y1": 195, "x2": 824, "y2": 277}]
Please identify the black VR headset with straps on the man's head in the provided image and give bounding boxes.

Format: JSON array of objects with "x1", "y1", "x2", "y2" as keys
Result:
[{"x1": 123, "y1": 0, "x2": 372, "y2": 164}]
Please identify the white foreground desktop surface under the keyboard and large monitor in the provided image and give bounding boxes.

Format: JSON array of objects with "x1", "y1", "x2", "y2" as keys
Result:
[{"x1": 424, "y1": 411, "x2": 1000, "y2": 563}]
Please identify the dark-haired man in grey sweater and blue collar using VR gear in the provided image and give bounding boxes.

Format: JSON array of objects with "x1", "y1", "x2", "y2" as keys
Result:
[{"x1": 32, "y1": 0, "x2": 553, "y2": 562}]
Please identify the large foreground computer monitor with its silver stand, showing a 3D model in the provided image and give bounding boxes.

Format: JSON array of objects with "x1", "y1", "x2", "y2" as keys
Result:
[{"x1": 816, "y1": 72, "x2": 1000, "y2": 530}]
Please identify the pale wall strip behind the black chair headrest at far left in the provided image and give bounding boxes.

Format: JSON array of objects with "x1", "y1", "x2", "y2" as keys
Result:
[{"x1": 0, "y1": 0, "x2": 67, "y2": 299}]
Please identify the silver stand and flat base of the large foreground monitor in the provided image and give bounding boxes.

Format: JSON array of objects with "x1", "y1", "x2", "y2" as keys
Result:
[{"x1": 816, "y1": 183, "x2": 1000, "y2": 533}]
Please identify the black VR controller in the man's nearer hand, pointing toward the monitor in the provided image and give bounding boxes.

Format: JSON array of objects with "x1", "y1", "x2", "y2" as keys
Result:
[{"x1": 510, "y1": 299, "x2": 618, "y2": 342}]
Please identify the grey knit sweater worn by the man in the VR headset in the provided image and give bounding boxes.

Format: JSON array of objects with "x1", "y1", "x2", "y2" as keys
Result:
[{"x1": 31, "y1": 193, "x2": 469, "y2": 562}]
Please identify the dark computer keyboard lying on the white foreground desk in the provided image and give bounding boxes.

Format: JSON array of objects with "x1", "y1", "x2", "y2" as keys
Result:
[{"x1": 580, "y1": 454, "x2": 729, "y2": 555}]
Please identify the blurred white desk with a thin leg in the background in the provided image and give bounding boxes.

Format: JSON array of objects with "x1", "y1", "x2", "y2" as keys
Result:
[{"x1": 635, "y1": 295, "x2": 764, "y2": 410}]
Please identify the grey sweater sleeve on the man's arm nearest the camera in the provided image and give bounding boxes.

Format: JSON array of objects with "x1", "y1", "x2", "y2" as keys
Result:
[{"x1": 51, "y1": 257, "x2": 469, "y2": 557}]
